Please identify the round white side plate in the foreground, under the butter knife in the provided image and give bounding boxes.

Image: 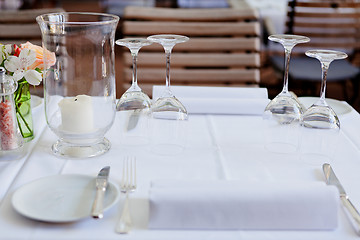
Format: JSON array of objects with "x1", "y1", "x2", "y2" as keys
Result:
[{"x1": 12, "y1": 174, "x2": 120, "y2": 222}]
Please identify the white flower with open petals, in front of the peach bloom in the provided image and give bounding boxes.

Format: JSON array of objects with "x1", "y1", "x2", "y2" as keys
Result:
[{"x1": 4, "y1": 49, "x2": 42, "y2": 85}]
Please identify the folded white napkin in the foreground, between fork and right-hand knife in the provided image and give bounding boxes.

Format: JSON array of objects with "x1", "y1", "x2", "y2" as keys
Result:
[{"x1": 149, "y1": 180, "x2": 339, "y2": 230}]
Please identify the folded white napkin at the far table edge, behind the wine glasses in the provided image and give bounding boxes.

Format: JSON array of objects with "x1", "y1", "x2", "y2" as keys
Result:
[{"x1": 153, "y1": 86, "x2": 269, "y2": 115}]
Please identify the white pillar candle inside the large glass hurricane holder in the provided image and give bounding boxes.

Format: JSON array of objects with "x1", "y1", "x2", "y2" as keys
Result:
[{"x1": 59, "y1": 95, "x2": 94, "y2": 133}]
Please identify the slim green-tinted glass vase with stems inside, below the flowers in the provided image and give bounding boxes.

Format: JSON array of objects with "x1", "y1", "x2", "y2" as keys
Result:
[{"x1": 14, "y1": 79, "x2": 34, "y2": 142}]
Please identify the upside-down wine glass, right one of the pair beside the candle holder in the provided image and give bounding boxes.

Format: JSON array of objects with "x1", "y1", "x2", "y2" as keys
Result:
[{"x1": 148, "y1": 34, "x2": 189, "y2": 155}]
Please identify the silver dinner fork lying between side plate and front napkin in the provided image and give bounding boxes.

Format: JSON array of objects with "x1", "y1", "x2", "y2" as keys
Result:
[{"x1": 115, "y1": 157, "x2": 136, "y2": 233}]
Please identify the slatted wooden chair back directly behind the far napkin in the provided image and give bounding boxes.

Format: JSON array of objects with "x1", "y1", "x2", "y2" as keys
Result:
[{"x1": 122, "y1": 7, "x2": 260, "y2": 95}]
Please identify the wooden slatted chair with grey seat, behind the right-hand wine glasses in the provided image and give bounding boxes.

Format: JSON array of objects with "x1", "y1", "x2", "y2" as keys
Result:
[{"x1": 271, "y1": 0, "x2": 360, "y2": 102}]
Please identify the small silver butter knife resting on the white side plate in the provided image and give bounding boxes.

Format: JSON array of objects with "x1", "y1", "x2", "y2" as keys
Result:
[{"x1": 91, "y1": 166, "x2": 110, "y2": 218}]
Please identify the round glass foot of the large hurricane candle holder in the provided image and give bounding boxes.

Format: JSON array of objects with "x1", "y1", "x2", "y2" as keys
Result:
[{"x1": 52, "y1": 138, "x2": 111, "y2": 158}]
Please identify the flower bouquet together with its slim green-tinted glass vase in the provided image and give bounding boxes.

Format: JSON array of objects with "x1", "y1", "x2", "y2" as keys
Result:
[{"x1": 0, "y1": 42, "x2": 56, "y2": 141}]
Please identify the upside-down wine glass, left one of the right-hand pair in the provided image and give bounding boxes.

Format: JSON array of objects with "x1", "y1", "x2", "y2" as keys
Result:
[{"x1": 263, "y1": 34, "x2": 310, "y2": 153}]
